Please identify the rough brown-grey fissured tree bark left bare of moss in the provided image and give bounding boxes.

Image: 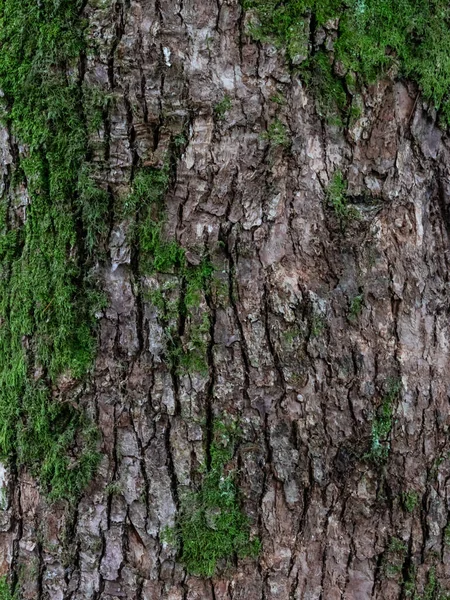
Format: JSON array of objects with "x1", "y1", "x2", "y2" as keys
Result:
[{"x1": 0, "y1": 0, "x2": 450, "y2": 600}]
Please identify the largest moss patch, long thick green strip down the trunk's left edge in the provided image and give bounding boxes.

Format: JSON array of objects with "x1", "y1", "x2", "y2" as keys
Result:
[{"x1": 0, "y1": 0, "x2": 107, "y2": 498}]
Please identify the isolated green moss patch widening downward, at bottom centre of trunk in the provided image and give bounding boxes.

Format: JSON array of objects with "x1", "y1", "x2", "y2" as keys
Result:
[{"x1": 166, "y1": 421, "x2": 260, "y2": 577}]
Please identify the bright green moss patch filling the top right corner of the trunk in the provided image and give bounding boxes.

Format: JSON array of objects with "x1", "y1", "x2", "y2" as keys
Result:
[{"x1": 244, "y1": 0, "x2": 450, "y2": 123}]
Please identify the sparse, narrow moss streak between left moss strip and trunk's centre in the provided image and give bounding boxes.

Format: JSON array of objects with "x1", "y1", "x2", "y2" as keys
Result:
[{"x1": 124, "y1": 161, "x2": 213, "y2": 374}]
